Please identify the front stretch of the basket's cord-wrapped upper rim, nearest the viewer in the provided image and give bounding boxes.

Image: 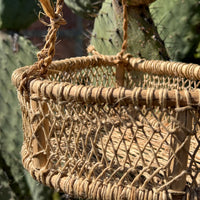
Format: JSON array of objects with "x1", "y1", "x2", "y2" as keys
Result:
[{"x1": 12, "y1": 79, "x2": 200, "y2": 108}]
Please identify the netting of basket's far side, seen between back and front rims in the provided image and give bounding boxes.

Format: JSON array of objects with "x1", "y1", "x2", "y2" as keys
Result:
[{"x1": 48, "y1": 63, "x2": 200, "y2": 90}]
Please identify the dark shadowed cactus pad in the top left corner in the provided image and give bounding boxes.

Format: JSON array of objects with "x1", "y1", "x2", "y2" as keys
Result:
[{"x1": 0, "y1": 0, "x2": 39, "y2": 31}]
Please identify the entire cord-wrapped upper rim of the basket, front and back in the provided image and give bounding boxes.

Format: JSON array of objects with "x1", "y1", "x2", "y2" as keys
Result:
[{"x1": 12, "y1": 55, "x2": 200, "y2": 107}]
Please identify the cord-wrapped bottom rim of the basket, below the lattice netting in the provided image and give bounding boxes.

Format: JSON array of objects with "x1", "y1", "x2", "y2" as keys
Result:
[{"x1": 22, "y1": 144, "x2": 200, "y2": 200}]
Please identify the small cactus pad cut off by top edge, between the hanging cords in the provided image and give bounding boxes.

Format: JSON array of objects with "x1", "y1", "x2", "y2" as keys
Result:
[{"x1": 64, "y1": 0, "x2": 104, "y2": 18}]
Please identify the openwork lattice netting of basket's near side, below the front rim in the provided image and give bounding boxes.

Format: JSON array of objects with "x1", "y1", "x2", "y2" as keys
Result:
[{"x1": 19, "y1": 89, "x2": 200, "y2": 197}]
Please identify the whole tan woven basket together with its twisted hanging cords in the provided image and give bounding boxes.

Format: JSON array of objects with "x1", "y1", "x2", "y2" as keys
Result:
[{"x1": 12, "y1": 0, "x2": 200, "y2": 200}]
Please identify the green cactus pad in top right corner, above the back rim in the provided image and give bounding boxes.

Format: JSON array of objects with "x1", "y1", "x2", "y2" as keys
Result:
[{"x1": 150, "y1": 0, "x2": 200, "y2": 62}]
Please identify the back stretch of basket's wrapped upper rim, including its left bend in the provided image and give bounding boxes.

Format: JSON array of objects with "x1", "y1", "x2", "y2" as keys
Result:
[{"x1": 12, "y1": 55, "x2": 200, "y2": 87}]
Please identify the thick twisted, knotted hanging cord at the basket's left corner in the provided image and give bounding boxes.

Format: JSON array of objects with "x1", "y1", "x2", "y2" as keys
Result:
[{"x1": 19, "y1": 0, "x2": 66, "y2": 93}]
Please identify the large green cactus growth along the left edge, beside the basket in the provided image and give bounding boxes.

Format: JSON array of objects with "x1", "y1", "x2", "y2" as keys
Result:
[{"x1": 0, "y1": 31, "x2": 51, "y2": 200}]
